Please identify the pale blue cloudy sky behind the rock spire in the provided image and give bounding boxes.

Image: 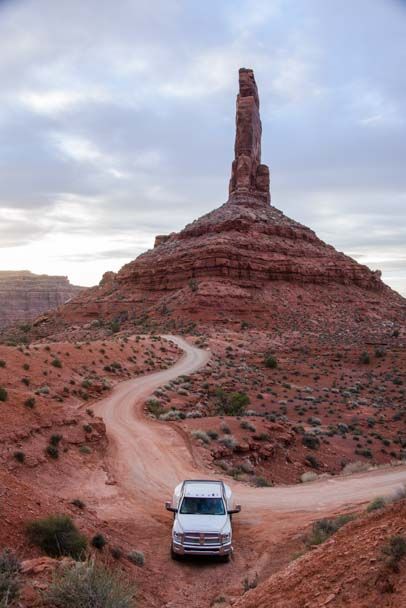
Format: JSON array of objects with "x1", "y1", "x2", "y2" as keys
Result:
[{"x1": 0, "y1": 0, "x2": 406, "y2": 294}]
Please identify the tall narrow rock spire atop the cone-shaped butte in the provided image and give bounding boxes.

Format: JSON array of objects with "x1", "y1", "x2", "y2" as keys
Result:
[{"x1": 229, "y1": 68, "x2": 271, "y2": 205}]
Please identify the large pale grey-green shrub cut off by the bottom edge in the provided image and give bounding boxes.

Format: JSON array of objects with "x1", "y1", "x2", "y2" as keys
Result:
[{"x1": 46, "y1": 560, "x2": 135, "y2": 608}]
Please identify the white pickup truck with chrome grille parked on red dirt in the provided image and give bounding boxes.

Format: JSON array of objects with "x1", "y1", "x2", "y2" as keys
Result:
[{"x1": 165, "y1": 479, "x2": 241, "y2": 561}]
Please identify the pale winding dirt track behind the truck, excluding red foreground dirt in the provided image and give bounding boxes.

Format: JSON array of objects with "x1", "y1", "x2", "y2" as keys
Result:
[{"x1": 96, "y1": 336, "x2": 406, "y2": 523}]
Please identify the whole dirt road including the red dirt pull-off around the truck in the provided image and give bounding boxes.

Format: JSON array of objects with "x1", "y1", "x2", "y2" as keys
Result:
[{"x1": 89, "y1": 336, "x2": 406, "y2": 608}]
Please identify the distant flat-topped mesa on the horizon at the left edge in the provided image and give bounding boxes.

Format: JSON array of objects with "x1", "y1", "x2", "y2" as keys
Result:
[{"x1": 0, "y1": 270, "x2": 83, "y2": 329}]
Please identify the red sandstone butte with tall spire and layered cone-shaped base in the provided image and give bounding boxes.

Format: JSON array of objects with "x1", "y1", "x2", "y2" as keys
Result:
[{"x1": 39, "y1": 68, "x2": 405, "y2": 328}]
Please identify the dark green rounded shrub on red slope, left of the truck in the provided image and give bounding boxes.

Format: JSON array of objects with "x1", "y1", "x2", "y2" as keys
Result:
[{"x1": 26, "y1": 515, "x2": 87, "y2": 559}]
